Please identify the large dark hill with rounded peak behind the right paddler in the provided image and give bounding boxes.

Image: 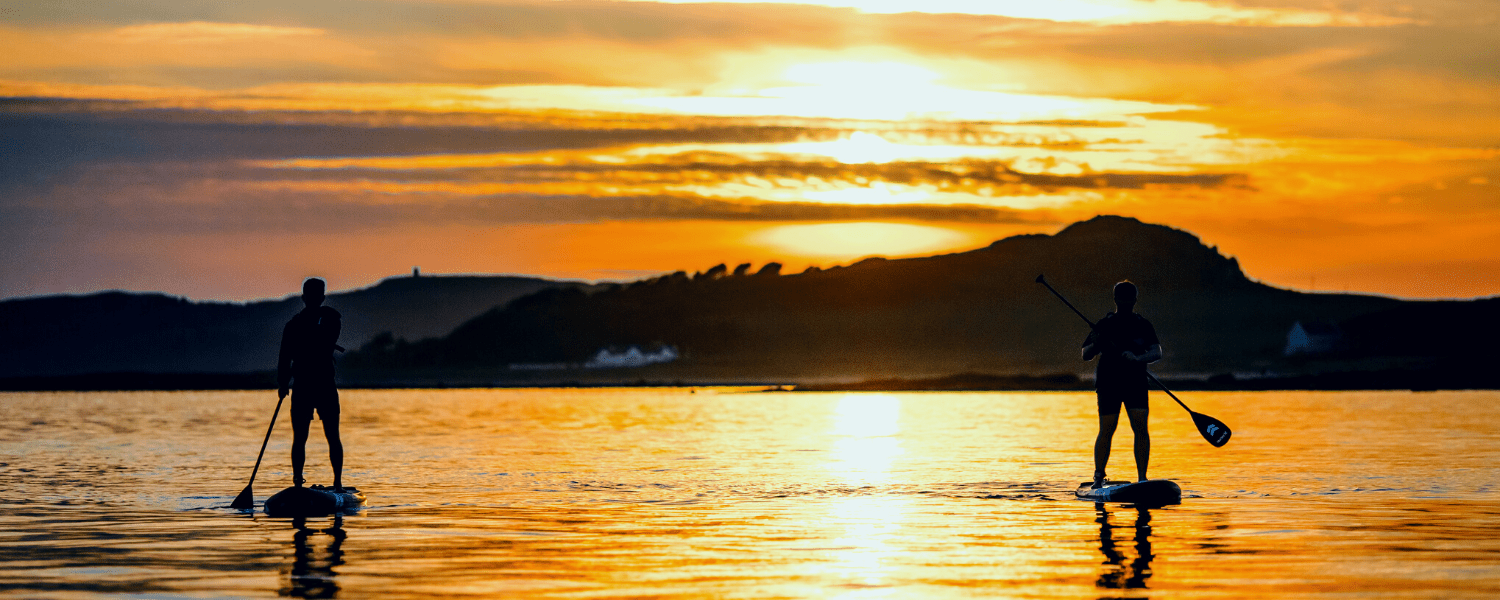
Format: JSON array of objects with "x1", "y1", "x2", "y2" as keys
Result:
[{"x1": 347, "y1": 216, "x2": 1401, "y2": 381}]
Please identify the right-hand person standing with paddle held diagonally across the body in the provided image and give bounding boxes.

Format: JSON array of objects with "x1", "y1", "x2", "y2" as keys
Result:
[{"x1": 1083, "y1": 281, "x2": 1161, "y2": 488}]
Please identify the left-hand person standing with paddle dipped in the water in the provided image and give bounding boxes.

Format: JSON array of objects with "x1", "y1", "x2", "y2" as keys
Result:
[{"x1": 276, "y1": 278, "x2": 344, "y2": 491}]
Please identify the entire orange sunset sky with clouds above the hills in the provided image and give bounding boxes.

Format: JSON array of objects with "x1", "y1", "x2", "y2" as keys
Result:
[{"x1": 0, "y1": 0, "x2": 1500, "y2": 300}]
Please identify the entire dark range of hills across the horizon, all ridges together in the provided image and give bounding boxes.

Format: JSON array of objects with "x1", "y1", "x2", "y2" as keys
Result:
[{"x1": 0, "y1": 216, "x2": 1500, "y2": 389}]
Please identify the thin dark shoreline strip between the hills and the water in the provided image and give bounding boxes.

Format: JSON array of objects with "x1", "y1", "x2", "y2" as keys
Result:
[{"x1": 0, "y1": 369, "x2": 1500, "y2": 392}]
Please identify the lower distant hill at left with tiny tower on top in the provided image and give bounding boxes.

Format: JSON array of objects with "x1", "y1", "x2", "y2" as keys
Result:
[{"x1": 0, "y1": 276, "x2": 579, "y2": 378}]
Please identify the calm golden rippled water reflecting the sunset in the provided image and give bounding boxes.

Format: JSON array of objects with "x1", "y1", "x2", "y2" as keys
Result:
[{"x1": 0, "y1": 389, "x2": 1500, "y2": 599}]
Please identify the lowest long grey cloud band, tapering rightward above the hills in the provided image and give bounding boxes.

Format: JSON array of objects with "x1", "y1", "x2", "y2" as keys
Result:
[{"x1": 0, "y1": 167, "x2": 1056, "y2": 240}]
